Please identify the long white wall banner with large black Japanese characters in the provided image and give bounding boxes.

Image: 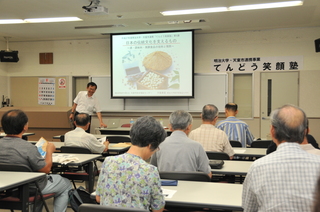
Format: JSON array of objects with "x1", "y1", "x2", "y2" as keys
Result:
[{"x1": 212, "y1": 56, "x2": 303, "y2": 72}]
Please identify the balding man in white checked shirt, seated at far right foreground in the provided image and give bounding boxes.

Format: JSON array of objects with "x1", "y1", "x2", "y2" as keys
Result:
[{"x1": 242, "y1": 105, "x2": 320, "y2": 212}]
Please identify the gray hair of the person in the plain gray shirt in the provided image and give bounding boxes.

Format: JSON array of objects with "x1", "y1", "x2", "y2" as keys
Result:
[{"x1": 169, "y1": 110, "x2": 193, "y2": 130}]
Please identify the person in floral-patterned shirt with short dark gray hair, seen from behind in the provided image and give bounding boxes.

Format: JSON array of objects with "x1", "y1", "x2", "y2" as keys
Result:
[{"x1": 96, "y1": 116, "x2": 167, "y2": 212}]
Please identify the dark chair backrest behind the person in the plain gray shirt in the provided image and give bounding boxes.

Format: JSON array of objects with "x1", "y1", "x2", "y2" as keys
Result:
[{"x1": 159, "y1": 172, "x2": 211, "y2": 182}]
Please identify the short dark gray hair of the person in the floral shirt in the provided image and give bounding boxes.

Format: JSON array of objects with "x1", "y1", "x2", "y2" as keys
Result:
[{"x1": 130, "y1": 116, "x2": 167, "y2": 150}]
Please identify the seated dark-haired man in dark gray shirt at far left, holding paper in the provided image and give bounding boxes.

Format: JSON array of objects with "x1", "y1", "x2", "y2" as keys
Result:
[{"x1": 0, "y1": 110, "x2": 72, "y2": 212}]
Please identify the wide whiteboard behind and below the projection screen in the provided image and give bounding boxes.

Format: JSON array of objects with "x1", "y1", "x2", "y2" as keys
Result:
[{"x1": 91, "y1": 74, "x2": 228, "y2": 111}]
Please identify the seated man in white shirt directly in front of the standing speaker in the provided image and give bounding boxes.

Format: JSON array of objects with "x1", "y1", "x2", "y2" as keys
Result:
[{"x1": 64, "y1": 113, "x2": 109, "y2": 153}]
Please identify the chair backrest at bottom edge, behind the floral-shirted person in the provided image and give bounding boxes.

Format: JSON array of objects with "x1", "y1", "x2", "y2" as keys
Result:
[{"x1": 78, "y1": 203, "x2": 149, "y2": 212}]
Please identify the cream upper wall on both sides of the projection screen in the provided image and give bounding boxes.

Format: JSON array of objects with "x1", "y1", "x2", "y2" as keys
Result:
[{"x1": 0, "y1": 27, "x2": 320, "y2": 140}]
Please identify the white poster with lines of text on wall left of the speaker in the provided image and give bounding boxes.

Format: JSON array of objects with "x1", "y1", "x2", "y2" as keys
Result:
[{"x1": 38, "y1": 78, "x2": 55, "y2": 105}]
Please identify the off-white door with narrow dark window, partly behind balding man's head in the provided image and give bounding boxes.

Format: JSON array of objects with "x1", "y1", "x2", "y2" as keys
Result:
[{"x1": 260, "y1": 71, "x2": 299, "y2": 139}]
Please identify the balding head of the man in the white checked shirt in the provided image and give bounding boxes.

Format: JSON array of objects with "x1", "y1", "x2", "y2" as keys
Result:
[{"x1": 270, "y1": 105, "x2": 308, "y2": 143}]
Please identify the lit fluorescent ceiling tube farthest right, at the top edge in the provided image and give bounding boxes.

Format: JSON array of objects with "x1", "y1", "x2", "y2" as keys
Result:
[{"x1": 229, "y1": 1, "x2": 303, "y2": 11}]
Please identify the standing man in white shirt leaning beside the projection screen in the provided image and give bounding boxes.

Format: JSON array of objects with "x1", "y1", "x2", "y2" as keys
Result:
[{"x1": 69, "y1": 82, "x2": 107, "y2": 133}]
